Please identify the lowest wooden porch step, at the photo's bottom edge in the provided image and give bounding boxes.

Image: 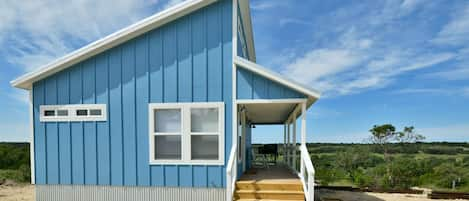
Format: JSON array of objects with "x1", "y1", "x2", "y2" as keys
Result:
[{"x1": 235, "y1": 190, "x2": 305, "y2": 200}]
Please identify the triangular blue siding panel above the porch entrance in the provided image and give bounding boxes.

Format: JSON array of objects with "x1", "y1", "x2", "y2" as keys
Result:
[{"x1": 236, "y1": 67, "x2": 306, "y2": 99}]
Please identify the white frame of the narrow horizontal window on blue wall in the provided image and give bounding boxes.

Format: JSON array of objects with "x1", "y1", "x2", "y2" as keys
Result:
[{"x1": 39, "y1": 104, "x2": 107, "y2": 122}]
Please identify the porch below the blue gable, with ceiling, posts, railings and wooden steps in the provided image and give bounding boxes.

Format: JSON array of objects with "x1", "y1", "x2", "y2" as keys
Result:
[{"x1": 228, "y1": 98, "x2": 314, "y2": 200}]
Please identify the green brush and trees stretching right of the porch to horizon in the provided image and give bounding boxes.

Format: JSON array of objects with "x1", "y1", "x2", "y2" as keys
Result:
[{"x1": 253, "y1": 142, "x2": 469, "y2": 192}]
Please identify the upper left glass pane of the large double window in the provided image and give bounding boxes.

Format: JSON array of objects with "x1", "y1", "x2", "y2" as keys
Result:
[{"x1": 154, "y1": 109, "x2": 181, "y2": 133}]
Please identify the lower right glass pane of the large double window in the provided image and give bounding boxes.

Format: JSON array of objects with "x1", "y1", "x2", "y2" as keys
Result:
[{"x1": 191, "y1": 135, "x2": 218, "y2": 160}]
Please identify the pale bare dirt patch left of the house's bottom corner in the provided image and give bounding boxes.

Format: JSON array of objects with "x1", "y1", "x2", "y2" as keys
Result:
[{"x1": 0, "y1": 184, "x2": 35, "y2": 201}]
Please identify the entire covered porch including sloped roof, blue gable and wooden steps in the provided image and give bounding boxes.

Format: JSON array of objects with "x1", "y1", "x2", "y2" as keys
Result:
[{"x1": 226, "y1": 56, "x2": 320, "y2": 201}]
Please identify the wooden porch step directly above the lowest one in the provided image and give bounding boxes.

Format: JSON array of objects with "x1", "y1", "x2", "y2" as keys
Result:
[{"x1": 236, "y1": 181, "x2": 303, "y2": 191}]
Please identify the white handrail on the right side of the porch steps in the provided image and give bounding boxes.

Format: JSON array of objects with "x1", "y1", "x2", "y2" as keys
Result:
[{"x1": 299, "y1": 144, "x2": 315, "y2": 201}]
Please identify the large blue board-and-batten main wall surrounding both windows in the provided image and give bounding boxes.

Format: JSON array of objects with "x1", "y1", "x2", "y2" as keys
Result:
[{"x1": 33, "y1": 1, "x2": 232, "y2": 187}]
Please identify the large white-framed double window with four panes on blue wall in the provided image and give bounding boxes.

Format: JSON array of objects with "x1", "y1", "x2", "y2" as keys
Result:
[{"x1": 149, "y1": 102, "x2": 224, "y2": 165}]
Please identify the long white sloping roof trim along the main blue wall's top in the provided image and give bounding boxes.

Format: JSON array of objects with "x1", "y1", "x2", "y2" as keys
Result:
[{"x1": 10, "y1": 0, "x2": 216, "y2": 89}]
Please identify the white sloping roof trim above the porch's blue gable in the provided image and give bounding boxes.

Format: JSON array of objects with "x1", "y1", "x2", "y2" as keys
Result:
[{"x1": 234, "y1": 56, "x2": 321, "y2": 99}]
